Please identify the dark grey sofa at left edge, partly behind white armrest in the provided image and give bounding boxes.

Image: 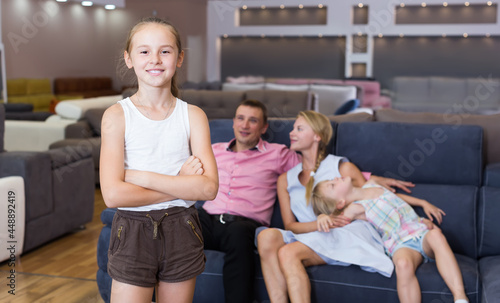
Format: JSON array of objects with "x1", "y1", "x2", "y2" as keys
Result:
[{"x1": 0, "y1": 104, "x2": 95, "y2": 253}]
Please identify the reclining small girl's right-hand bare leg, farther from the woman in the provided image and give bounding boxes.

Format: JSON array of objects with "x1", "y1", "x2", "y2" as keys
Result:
[{"x1": 423, "y1": 228, "x2": 467, "y2": 301}]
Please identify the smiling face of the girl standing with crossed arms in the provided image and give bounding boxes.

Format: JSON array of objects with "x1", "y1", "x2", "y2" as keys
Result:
[{"x1": 124, "y1": 23, "x2": 184, "y2": 87}]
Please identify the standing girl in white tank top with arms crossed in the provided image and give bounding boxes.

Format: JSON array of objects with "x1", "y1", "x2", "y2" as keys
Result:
[{"x1": 100, "y1": 18, "x2": 218, "y2": 302}]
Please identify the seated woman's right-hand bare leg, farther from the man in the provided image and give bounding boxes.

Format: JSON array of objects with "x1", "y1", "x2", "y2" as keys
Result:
[{"x1": 278, "y1": 242, "x2": 325, "y2": 303}]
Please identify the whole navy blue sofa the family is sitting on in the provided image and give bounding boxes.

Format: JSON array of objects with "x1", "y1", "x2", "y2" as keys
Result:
[{"x1": 97, "y1": 110, "x2": 500, "y2": 303}]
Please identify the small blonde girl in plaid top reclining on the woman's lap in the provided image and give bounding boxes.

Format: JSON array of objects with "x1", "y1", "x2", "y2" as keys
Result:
[{"x1": 312, "y1": 177, "x2": 469, "y2": 303}]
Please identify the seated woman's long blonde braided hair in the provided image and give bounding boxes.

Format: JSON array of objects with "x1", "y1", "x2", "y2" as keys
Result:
[{"x1": 297, "y1": 110, "x2": 333, "y2": 204}]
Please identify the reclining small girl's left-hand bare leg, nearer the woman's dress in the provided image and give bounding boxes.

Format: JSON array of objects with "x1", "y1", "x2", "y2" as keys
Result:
[{"x1": 392, "y1": 247, "x2": 422, "y2": 303}]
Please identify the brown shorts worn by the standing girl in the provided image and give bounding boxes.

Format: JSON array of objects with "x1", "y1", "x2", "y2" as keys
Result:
[{"x1": 108, "y1": 207, "x2": 205, "y2": 287}]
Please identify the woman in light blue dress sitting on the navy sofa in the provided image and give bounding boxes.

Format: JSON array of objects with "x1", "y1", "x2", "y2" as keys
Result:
[{"x1": 257, "y1": 111, "x2": 412, "y2": 303}]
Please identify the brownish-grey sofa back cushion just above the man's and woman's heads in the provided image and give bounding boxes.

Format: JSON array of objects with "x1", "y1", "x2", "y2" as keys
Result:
[{"x1": 245, "y1": 90, "x2": 312, "y2": 118}]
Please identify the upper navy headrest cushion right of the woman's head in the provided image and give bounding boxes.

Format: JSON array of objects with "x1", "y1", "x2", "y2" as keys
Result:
[{"x1": 336, "y1": 122, "x2": 482, "y2": 186}]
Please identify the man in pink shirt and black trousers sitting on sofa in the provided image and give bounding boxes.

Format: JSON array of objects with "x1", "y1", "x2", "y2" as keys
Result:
[{"x1": 198, "y1": 100, "x2": 413, "y2": 303}]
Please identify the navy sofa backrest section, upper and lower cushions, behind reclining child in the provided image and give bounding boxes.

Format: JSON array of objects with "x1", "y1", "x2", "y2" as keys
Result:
[{"x1": 336, "y1": 122, "x2": 482, "y2": 258}]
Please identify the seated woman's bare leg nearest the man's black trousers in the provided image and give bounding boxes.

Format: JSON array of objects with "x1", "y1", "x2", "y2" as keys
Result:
[{"x1": 257, "y1": 228, "x2": 288, "y2": 303}]
